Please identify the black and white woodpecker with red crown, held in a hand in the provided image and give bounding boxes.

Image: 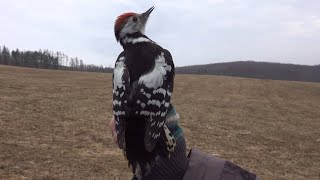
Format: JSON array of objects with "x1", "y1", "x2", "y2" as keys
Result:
[{"x1": 113, "y1": 7, "x2": 176, "y2": 179}]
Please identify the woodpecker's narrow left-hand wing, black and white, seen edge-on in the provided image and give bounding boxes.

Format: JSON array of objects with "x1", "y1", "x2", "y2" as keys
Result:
[{"x1": 112, "y1": 52, "x2": 130, "y2": 149}]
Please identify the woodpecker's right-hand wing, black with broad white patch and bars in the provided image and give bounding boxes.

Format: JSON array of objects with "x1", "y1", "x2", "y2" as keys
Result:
[{"x1": 134, "y1": 50, "x2": 174, "y2": 152}]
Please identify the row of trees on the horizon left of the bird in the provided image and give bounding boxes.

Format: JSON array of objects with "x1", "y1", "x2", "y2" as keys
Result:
[{"x1": 0, "y1": 46, "x2": 112, "y2": 72}]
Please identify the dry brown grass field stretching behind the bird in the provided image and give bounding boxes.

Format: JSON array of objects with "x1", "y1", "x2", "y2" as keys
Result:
[{"x1": 0, "y1": 66, "x2": 320, "y2": 180}]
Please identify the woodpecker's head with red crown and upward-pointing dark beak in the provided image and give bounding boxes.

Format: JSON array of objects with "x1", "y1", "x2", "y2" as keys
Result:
[{"x1": 114, "y1": 7, "x2": 154, "y2": 41}]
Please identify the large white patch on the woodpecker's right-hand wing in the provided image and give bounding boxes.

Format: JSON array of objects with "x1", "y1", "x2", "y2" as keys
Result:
[{"x1": 139, "y1": 52, "x2": 172, "y2": 89}]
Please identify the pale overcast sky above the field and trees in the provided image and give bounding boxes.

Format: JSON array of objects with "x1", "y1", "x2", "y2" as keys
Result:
[{"x1": 0, "y1": 0, "x2": 320, "y2": 66}]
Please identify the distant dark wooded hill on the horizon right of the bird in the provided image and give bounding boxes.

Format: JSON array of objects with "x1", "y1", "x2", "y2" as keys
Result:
[{"x1": 176, "y1": 61, "x2": 320, "y2": 82}]
